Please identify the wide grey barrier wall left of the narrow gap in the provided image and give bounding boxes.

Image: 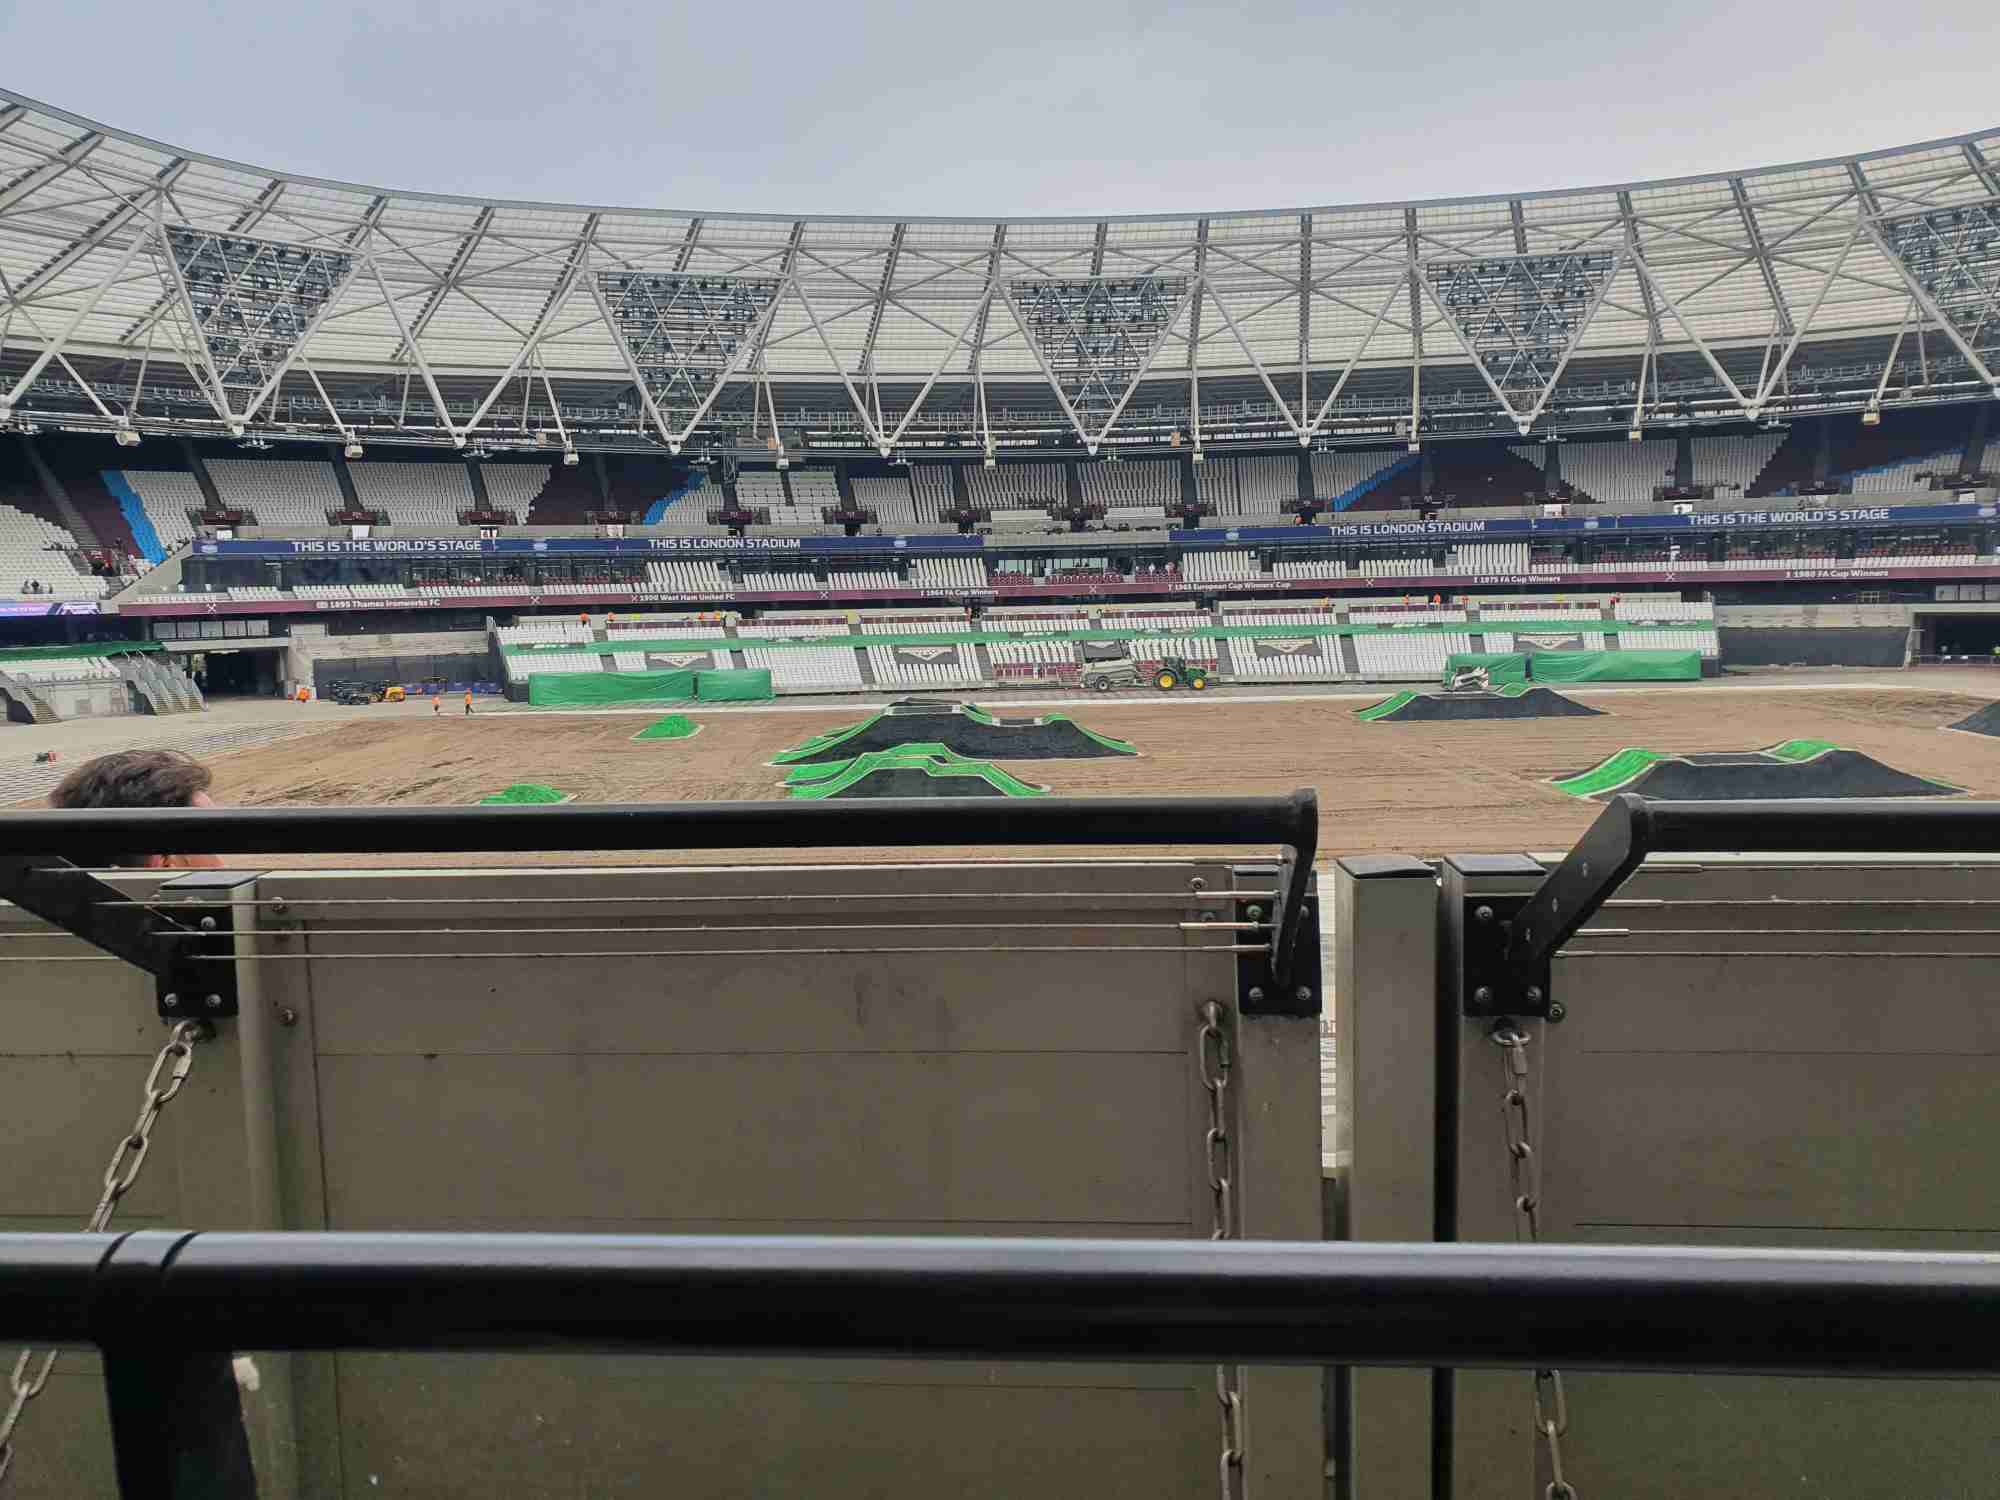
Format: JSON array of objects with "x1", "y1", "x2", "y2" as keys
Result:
[{"x1": 0, "y1": 860, "x2": 1326, "y2": 1500}]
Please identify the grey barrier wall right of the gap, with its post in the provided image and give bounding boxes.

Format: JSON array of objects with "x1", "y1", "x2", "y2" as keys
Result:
[{"x1": 1334, "y1": 856, "x2": 2000, "y2": 1500}]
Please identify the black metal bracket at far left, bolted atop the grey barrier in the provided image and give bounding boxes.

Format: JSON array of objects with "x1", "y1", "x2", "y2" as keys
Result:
[{"x1": 0, "y1": 854, "x2": 256, "y2": 1020}]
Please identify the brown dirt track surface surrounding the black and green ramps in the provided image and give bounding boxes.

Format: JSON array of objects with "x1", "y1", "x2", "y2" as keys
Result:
[{"x1": 180, "y1": 686, "x2": 2000, "y2": 866}]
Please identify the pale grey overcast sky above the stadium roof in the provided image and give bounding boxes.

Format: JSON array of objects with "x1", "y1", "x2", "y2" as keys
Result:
[{"x1": 0, "y1": 0, "x2": 2000, "y2": 216}]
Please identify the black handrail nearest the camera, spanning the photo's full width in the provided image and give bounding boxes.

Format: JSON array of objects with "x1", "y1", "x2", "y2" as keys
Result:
[{"x1": 0, "y1": 1230, "x2": 2000, "y2": 1376}]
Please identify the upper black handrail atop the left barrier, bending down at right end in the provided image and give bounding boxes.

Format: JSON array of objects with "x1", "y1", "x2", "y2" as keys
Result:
[{"x1": 0, "y1": 790, "x2": 1320, "y2": 994}]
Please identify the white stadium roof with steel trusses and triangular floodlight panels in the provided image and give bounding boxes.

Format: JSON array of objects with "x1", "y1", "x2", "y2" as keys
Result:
[{"x1": 0, "y1": 90, "x2": 2000, "y2": 458}]
